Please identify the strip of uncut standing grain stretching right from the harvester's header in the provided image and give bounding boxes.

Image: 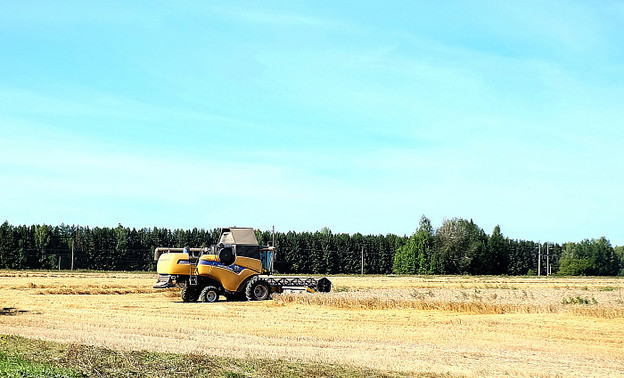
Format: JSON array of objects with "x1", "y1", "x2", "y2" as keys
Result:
[{"x1": 275, "y1": 278, "x2": 624, "y2": 319}]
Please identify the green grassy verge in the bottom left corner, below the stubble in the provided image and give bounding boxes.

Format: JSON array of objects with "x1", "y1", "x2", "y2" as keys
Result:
[{"x1": 0, "y1": 335, "x2": 412, "y2": 377}]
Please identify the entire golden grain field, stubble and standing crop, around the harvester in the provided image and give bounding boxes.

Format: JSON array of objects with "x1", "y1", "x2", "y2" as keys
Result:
[{"x1": 0, "y1": 271, "x2": 624, "y2": 376}]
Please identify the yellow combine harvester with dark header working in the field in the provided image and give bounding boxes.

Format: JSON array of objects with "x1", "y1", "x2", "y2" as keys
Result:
[{"x1": 154, "y1": 227, "x2": 331, "y2": 302}]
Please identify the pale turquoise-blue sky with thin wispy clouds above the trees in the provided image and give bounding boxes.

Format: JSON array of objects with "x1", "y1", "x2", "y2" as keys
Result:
[{"x1": 0, "y1": 0, "x2": 624, "y2": 245}]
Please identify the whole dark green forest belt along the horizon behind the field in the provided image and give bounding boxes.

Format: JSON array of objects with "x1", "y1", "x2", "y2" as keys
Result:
[{"x1": 0, "y1": 215, "x2": 624, "y2": 276}]
